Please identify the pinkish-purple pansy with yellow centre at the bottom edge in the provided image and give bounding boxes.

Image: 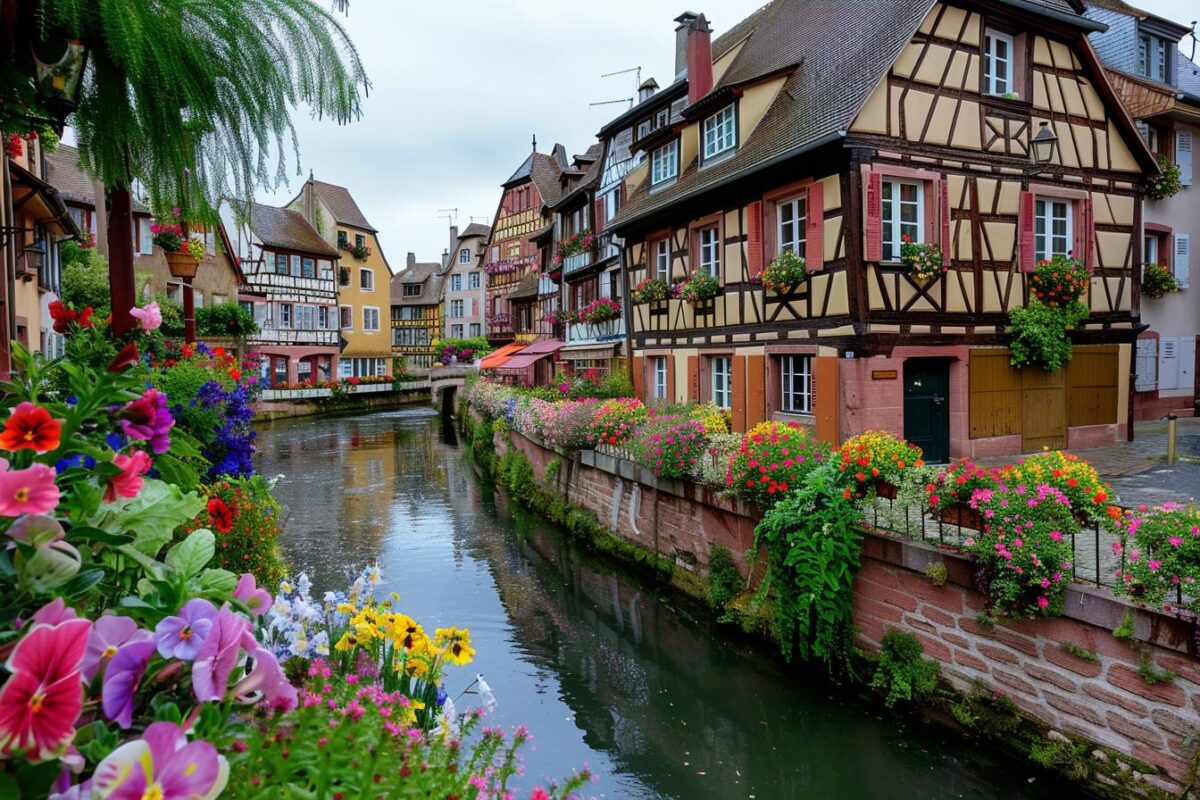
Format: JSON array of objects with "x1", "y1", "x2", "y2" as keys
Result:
[{"x1": 92, "y1": 722, "x2": 229, "y2": 800}]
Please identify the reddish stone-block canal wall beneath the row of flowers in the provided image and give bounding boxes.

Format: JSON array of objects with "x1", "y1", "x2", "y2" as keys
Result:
[{"x1": 497, "y1": 424, "x2": 1200, "y2": 792}]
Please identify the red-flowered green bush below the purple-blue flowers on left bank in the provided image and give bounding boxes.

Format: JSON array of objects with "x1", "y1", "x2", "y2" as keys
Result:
[{"x1": 182, "y1": 475, "x2": 284, "y2": 587}]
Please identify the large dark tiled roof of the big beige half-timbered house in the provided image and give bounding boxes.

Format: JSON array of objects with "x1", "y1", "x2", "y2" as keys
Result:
[{"x1": 608, "y1": 0, "x2": 1118, "y2": 230}]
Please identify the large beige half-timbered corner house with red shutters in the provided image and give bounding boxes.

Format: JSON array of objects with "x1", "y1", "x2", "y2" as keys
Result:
[{"x1": 612, "y1": 0, "x2": 1157, "y2": 461}]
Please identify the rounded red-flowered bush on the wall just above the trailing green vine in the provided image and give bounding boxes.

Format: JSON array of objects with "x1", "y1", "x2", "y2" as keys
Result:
[{"x1": 725, "y1": 422, "x2": 830, "y2": 510}]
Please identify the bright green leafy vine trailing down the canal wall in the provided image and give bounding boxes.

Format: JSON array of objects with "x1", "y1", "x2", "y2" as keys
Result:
[{"x1": 755, "y1": 462, "x2": 863, "y2": 663}]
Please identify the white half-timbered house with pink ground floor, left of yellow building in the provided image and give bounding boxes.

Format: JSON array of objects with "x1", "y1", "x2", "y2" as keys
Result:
[{"x1": 221, "y1": 201, "x2": 341, "y2": 386}]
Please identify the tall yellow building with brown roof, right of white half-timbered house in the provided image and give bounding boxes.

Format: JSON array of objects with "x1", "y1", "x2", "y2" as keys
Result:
[{"x1": 288, "y1": 175, "x2": 391, "y2": 378}]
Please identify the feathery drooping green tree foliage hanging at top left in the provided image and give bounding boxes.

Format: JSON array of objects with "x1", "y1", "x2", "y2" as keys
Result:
[{"x1": 43, "y1": 0, "x2": 368, "y2": 218}]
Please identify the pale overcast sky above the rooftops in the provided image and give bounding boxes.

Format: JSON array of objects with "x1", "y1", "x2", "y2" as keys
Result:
[{"x1": 250, "y1": 0, "x2": 1200, "y2": 270}]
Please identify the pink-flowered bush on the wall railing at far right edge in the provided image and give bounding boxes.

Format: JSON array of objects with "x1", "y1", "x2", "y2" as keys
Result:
[{"x1": 1109, "y1": 503, "x2": 1200, "y2": 612}]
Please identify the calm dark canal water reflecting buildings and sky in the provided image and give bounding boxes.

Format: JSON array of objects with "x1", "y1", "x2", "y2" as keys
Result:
[{"x1": 258, "y1": 409, "x2": 1069, "y2": 800}]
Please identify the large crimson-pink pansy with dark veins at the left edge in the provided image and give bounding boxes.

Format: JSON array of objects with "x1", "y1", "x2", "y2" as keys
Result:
[{"x1": 0, "y1": 619, "x2": 91, "y2": 762}]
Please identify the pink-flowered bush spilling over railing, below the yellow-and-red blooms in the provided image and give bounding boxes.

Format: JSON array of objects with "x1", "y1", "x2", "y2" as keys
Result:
[{"x1": 964, "y1": 483, "x2": 1078, "y2": 618}]
